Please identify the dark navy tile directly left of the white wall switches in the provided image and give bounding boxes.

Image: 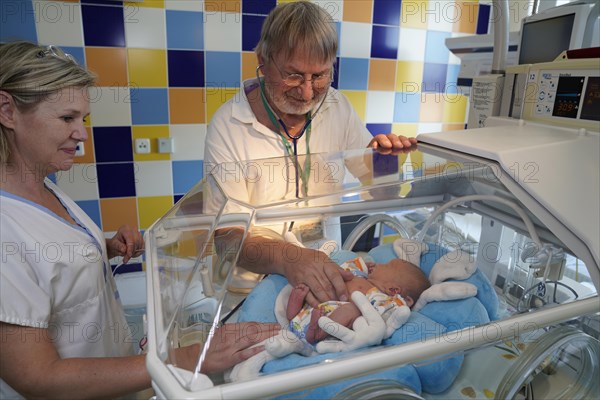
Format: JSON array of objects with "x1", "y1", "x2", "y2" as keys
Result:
[{"x1": 93, "y1": 126, "x2": 133, "y2": 163}]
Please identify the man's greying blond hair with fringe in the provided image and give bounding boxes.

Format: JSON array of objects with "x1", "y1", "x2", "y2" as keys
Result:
[{"x1": 255, "y1": 1, "x2": 338, "y2": 63}]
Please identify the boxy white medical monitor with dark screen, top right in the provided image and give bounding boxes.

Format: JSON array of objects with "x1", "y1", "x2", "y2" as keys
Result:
[{"x1": 519, "y1": 0, "x2": 600, "y2": 64}]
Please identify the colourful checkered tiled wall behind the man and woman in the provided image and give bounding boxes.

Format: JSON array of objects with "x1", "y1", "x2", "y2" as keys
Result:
[{"x1": 0, "y1": 0, "x2": 491, "y2": 247}]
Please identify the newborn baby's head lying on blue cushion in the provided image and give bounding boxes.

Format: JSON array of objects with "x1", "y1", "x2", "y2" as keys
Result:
[{"x1": 368, "y1": 259, "x2": 431, "y2": 307}]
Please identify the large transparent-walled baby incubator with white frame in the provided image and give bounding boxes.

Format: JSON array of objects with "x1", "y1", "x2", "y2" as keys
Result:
[{"x1": 146, "y1": 57, "x2": 600, "y2": 399}]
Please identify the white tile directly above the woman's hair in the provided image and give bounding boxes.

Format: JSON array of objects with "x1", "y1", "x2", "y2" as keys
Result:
[{"x1": 32, "y1": 0, "x2": 83, "y2": 47}]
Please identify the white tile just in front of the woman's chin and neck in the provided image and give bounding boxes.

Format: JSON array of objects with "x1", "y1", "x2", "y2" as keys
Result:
[{"x1": 56, "y1": 164, "x2": 100, "y2": 201}]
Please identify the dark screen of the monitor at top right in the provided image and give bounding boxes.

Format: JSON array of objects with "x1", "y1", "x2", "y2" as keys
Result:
[{"x1": 519, "y1": 14, "x2": 575, "y2": 64}]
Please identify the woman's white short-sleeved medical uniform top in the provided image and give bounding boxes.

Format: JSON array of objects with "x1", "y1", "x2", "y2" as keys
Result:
[{"x1": 0, "y1": 179, "x2": 134, "y2": 399}]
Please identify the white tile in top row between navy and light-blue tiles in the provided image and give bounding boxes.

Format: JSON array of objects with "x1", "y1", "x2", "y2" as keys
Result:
[{"x1": 124, "y1": 7, "x2": 167, "y2": 49}]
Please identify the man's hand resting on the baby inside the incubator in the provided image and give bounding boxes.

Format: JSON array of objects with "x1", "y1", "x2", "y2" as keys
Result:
[{"x1": 284, "y1": 248, "x2": 354, "y2": 307}]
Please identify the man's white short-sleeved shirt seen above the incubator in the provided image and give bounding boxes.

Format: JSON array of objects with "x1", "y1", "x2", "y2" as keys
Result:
[{"x1": 204, "y1": 79, "x2": 373, "y2": 205}]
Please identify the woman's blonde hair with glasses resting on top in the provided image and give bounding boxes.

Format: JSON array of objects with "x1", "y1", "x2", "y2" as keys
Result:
[{"x1": 0, "y1": 42, "x2": 96, "y2": 163}]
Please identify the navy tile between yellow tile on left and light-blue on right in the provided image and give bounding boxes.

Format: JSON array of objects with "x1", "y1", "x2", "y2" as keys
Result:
[{"x1": 167, "y1": 50, "x2": 204, "y2": 87}]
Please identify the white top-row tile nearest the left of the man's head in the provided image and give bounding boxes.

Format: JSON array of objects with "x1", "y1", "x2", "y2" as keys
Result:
[{"x1": 204, "y1": 12, "x2": 242, "y2": 51}]
